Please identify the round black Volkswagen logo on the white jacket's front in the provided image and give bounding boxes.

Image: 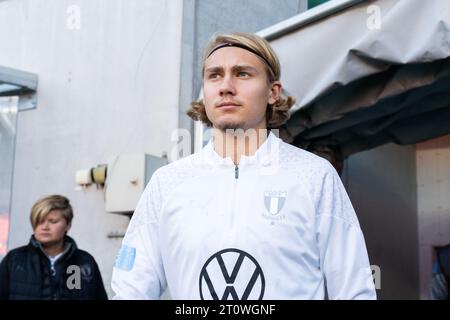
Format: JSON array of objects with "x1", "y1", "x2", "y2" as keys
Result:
[{"x1": 199, "y1": 248, "x2": 265, "y2": 300}]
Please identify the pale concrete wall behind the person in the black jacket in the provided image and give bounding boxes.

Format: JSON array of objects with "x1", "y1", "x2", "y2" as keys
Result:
[{"x1": 0, "y1": 0, "x2": 182, "y2": 295}]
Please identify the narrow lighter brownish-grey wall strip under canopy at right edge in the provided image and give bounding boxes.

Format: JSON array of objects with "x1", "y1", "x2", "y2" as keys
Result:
[{"x1": 416, "y1": 135, "x2": 450, "y2": 299}]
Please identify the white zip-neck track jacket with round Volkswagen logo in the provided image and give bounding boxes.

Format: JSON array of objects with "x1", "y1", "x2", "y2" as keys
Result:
[{"x1": 112, "y1": 133, "x2": 376, "y2": 300}]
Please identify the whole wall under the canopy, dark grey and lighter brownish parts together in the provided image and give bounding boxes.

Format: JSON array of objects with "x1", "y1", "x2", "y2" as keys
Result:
[{"x1": 343, "y1": 135, "x2": 450, "y2": 299}]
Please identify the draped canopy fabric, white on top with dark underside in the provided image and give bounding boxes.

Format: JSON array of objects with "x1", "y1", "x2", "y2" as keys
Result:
[{"x1": 270, "y1": 0, "x2": 450, "y2": 158}]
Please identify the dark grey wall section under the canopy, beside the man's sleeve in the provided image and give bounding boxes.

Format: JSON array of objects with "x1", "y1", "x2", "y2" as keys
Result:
[{"x1": 343, "y1": 144, "x2": 419, "y2": 299}]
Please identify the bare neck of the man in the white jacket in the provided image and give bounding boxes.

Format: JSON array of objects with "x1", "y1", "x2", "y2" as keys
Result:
[{"x1": 213, "y1": 128, "x2": 268, "y2": 165}]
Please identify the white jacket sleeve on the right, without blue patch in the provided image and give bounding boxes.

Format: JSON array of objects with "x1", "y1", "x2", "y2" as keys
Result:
[{"x1": 316, "y1": 166, "x2": 376, "y2": 300}]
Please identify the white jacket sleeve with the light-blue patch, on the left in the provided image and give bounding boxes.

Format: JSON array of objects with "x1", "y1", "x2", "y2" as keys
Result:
[{"x1": 111, "y1": 172, "x2": 167, "y2": 300}]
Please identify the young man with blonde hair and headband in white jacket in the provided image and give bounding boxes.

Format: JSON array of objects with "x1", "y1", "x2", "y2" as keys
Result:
[{"x1": 112, "y1": 33, "x2": 376, "y2": 300}]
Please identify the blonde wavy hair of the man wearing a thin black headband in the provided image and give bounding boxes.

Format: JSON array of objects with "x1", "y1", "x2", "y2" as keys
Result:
[{"x1": 187, "y1": 32, "x2": 295, "y2": 128}]
